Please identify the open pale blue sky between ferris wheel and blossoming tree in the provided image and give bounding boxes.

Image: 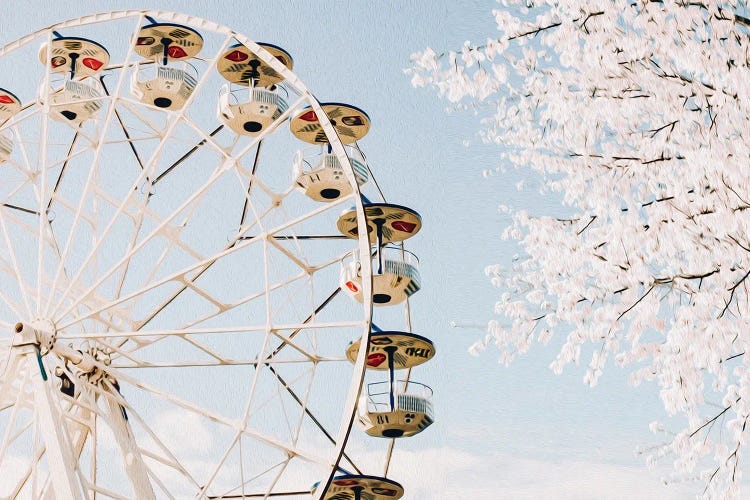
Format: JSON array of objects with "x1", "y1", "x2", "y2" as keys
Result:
[{"x1": 0, "y1": 0, "x2": 700, "y2": 500}]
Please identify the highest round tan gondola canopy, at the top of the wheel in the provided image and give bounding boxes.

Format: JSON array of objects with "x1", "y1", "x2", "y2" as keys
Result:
[{"x1": 133, "y1": 23, "x2": 203, "y2": 61}]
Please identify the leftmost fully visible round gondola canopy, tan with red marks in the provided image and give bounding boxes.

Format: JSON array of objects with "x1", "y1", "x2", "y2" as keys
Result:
[{"x1": 39, "y1": 37, "x2": 109, "y2": 79}]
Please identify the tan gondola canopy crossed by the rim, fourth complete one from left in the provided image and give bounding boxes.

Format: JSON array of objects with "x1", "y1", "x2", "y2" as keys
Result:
[{"x1": 290, "y1": 103, "x2": 370, "y2": 144}]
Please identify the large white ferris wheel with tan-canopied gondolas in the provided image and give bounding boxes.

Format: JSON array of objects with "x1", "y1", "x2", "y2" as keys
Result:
[{"x1": 0, "y1": 11, "x2": 435, "y2": 500}]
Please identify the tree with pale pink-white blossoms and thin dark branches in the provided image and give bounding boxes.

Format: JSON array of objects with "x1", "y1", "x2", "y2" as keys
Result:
[{"x1": 407, "y1": 0, "x2": 750, "y2": 498}]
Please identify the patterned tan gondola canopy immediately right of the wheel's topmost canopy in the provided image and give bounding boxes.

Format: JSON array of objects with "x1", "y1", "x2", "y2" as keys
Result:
[{"x1": 216, "y1": 43, "x2": 294, "y2": 87}]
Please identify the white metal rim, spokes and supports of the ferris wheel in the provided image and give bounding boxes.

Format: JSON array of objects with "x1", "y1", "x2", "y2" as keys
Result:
[{"x1": 0, "y1": 10, "x2": 382, "y2": 499}]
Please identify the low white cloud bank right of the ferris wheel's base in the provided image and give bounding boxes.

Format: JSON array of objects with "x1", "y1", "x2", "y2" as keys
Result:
[{"x1": 390, "y1": 447, "x2": 701, "y2": 500}]
